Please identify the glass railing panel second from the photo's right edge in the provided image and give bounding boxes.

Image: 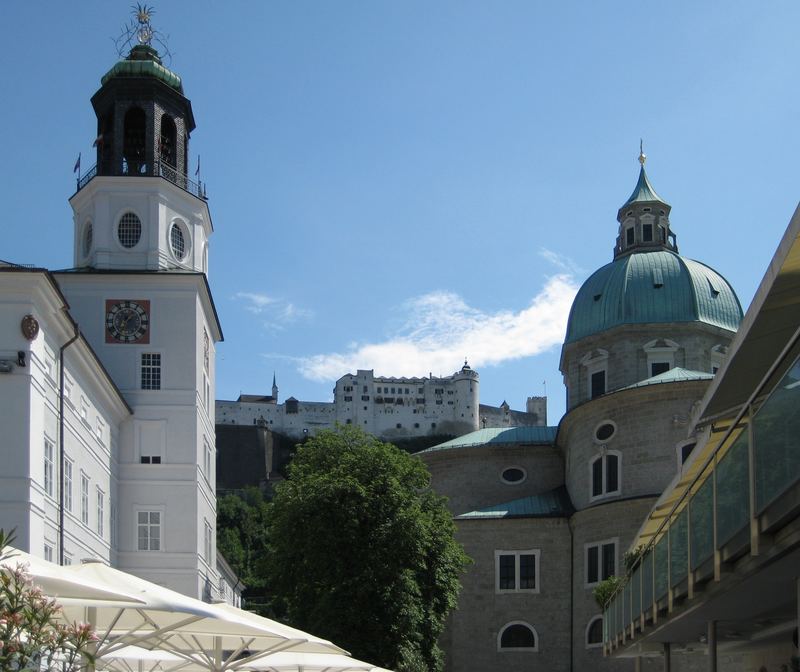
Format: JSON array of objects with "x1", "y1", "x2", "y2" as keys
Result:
[{"x1": 716, "y1": 427, "x2": 750, "y2": 548}]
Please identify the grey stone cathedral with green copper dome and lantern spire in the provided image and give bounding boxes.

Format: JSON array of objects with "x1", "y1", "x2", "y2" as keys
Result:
[{"x1": 420, "y1": 154, "x2": 742, "y2": 672}]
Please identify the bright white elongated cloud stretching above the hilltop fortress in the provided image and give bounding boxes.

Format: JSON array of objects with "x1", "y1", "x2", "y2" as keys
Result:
[{"x1": 298, "y1": 273, "x2": 577, "y2": 381}]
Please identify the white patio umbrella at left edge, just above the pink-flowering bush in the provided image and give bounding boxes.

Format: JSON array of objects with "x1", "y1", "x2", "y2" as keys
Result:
[{"x1": 0, "y1": 546, "x2": 143, "y2": 607}]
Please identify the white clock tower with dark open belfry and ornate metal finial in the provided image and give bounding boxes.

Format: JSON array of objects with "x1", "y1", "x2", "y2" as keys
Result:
[{"x1": 57, "y1": 5, "x2": 222, "y2": 598}]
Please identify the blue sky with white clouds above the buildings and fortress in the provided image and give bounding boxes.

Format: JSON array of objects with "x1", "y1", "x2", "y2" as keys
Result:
[{"x1": 0, "y1": 0, "x2": 800, "y2": 422}]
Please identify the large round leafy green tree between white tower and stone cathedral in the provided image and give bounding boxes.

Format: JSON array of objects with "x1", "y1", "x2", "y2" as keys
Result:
[{"x1": 265, "y1": 427, "x2": 469, "y2": 672}]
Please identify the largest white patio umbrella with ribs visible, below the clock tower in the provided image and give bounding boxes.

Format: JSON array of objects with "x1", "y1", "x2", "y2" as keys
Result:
[{"x1": 63, "y1": 562, "x2": 343, "y2": 672}]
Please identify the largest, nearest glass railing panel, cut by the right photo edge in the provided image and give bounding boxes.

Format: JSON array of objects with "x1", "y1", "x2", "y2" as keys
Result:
[{"x1": 753, "y1": 360, "x2": 800, "y2": 513}]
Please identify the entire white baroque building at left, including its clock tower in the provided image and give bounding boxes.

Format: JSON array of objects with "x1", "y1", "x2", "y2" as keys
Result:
[{"x1": 0, "y1": 32, "x2": 237, "y2": 602}]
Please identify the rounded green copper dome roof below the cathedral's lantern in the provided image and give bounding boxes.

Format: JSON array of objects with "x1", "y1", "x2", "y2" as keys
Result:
[{"x1": 565, "y1": 250, "x2": 742, "y2": 343}]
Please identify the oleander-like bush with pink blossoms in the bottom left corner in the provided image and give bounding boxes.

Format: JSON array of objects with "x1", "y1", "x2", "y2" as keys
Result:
[{"x1": 0, "y1": 529, "x2": 94, "y2": 672}]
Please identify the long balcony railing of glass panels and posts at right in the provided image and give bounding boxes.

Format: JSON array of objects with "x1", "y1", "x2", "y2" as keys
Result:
[{"x1": 603, "y1": 330, "x2": 800, "y2": 655}]
